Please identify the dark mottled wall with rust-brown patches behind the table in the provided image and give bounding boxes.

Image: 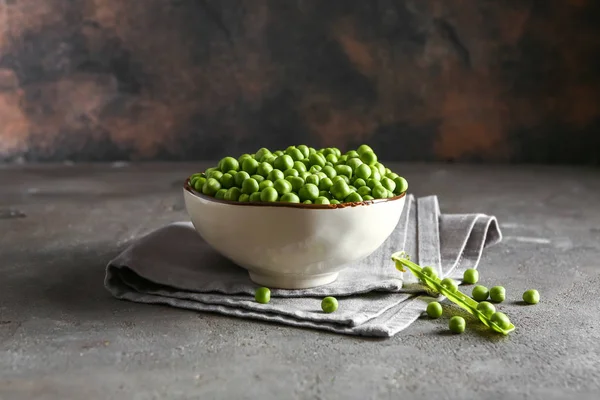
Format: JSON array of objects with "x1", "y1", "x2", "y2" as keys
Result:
[{"x1": 0, "y1": 0, "x2": 600, "y2": 164}]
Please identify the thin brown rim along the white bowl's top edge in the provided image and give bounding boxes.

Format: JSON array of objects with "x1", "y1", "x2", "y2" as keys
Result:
[{"x1": 183, "y1": 176, "x2": 406, "y2": 210}]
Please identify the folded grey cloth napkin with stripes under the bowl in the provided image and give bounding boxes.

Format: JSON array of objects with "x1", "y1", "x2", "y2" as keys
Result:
[{"x1": 104, "y1": 195, "x2": 502, "y2": 337}]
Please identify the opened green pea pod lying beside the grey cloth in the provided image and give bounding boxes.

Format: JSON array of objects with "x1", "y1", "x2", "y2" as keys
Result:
[{"x1": 392, "y1": 252, "x2": 515, "y2": 335}]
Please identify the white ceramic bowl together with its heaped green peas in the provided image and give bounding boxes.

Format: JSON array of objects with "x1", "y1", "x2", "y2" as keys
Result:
[{"x1": 183, "y1": 145, "x2": 408, "y2": 289}]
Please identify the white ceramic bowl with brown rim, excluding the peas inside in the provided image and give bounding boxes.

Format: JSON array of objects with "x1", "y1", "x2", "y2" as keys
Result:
[{"x1": 183, "y1": 181, "x2": 406, "y2": 289}]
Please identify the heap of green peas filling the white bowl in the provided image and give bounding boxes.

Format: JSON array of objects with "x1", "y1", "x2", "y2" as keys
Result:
[{"x1": 189, "y1": 144, "x2": 408, "y2": 204}]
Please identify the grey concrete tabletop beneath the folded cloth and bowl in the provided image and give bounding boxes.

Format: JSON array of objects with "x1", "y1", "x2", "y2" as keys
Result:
[{"x1": 0, "y1": 164, "x2": 600, "y2": 399}]
